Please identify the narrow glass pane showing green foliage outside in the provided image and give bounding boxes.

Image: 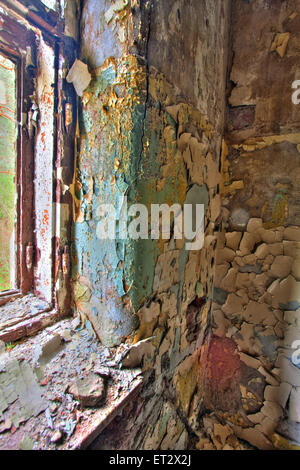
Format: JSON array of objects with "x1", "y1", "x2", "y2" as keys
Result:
[{"x1": 0, "y1": 54, "x2": 17, "y2": 291}]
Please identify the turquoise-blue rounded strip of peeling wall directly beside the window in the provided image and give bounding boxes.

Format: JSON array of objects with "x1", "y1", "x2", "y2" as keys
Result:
[{"x1": 72, "y1": 2, "x2": 148, "y2": 346}]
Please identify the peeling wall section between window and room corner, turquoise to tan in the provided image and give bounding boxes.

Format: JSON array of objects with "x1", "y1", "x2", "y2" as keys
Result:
[{"x1": 76, "y1": 0, "x2": 229, "y2": 449}]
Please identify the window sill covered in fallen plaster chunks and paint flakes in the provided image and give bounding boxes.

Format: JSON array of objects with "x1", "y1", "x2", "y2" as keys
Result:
[{"x1": 0, "y1": 320, "x2": 140, "y2": 450}]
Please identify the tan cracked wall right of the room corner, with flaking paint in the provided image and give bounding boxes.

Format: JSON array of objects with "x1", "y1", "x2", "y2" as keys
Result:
[{"x1": 210, "y1": 0, "x2": 300, "y2": 449}]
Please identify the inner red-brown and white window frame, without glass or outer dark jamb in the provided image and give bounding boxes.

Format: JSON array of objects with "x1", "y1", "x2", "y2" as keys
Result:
[{"x1": 0, "y1": 11, "x2": 56, "y2": 306}]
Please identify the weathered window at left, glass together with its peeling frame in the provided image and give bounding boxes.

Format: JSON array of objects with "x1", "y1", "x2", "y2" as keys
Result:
[{"x1": 0, "y1": 0, "x2": 67, "y2": 323}]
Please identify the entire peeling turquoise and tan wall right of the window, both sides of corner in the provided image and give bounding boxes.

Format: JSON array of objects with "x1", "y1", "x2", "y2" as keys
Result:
[{"x1": 71, "y1": 0, "x2": 300, "y2": 450}]
